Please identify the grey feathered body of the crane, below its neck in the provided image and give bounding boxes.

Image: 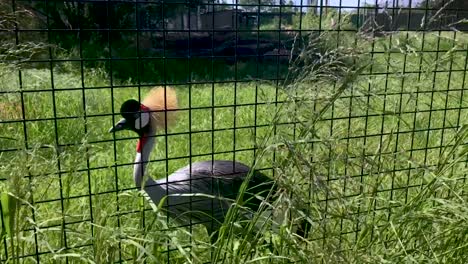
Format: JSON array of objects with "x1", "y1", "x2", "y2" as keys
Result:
[{"x1": 146, "y1": 160, "x2": 273, "y2": 234}]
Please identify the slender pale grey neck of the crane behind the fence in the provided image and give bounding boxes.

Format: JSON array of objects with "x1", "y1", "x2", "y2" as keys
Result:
[{"x1": 133, "y1": 132, "x2": 155, "y2": 188}]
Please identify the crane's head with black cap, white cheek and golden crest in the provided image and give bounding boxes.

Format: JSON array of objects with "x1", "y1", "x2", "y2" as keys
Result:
[{"x1": 109, "y1": 87, "x2": 177, "y2": 137}]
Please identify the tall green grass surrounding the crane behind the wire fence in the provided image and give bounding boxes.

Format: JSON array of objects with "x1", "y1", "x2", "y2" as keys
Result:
[{"x1": 0, "y1": 29, "x2": 468, "y2": 263}]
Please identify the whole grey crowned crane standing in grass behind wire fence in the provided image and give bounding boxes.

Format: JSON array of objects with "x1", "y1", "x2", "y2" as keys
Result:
[{"x1": 109, "y1": 87, "x2": 308, "y2": 242}]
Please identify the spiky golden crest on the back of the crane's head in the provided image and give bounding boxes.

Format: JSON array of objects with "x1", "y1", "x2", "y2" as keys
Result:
[{"x1": 142, "y1": 87, "x2": 177, "y2": 131}]
